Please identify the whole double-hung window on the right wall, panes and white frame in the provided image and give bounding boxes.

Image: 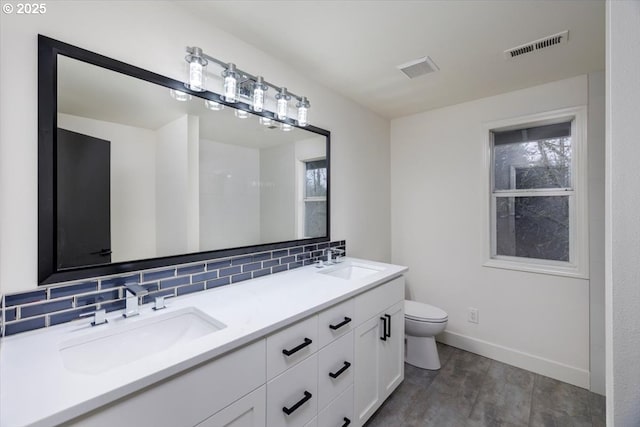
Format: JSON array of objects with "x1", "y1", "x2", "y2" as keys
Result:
[{"x1": 485, "y1": 109, "x2": 588, "y2": 277}]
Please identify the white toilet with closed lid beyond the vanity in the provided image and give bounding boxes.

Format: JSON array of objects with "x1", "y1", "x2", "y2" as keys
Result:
[{"x1": 404, "y1": 300, "x2": 449, "y2": 370}]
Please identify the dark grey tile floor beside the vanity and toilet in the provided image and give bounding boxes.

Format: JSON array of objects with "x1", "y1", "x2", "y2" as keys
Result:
[{"x1": 365, "y1": 344, "x2": 606, "y2": 427}]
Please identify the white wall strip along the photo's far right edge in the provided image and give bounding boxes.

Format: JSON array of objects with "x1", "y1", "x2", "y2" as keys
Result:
[{"x1": 606, "y1": 0, "x2": 640, "y2": 427}]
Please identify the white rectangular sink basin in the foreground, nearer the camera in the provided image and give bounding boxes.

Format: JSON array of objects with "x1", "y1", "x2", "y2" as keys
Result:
[{"x1": 59, "y1": 307, "x2": 226, "y2": 374}]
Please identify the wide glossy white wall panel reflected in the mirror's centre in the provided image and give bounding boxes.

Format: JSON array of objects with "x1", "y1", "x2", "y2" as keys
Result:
[{"x1": 200, "y1": 139, "x2": 260, "y2": 250}]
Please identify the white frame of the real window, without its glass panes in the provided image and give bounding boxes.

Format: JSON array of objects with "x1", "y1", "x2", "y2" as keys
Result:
[{"x1": 483, "y1": 106, "x2": 589, "y2": 279}]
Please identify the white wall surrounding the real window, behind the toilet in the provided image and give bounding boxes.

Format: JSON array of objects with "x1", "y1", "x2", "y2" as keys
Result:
[{"x1": 391, "y1": 76, "x2": 604, "y2": 387}]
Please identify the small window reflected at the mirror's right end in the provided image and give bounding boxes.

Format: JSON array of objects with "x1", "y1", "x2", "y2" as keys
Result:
[{"x1": 303, "y1": 159, "x2": 327, "y2": 238}]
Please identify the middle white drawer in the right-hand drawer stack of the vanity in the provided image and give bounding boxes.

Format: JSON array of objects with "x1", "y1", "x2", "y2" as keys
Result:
[{"x1": 318, "y1": 332, "x2": 355, "y2": 410}]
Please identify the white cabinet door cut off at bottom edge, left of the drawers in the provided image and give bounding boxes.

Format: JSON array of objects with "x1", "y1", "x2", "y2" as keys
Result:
[{"x1": 196, "y1": 386, "x2": 267, "y2": 427}]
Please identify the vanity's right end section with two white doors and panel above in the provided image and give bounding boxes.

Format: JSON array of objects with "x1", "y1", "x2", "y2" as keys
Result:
[{"x1": 354, "y1": 277, "x2": 404, "y2": 426}]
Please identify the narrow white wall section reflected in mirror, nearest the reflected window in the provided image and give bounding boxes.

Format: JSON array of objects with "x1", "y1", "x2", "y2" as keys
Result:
[{"x1": 260, "y1": 143, "x2": 297, "y2": 242}]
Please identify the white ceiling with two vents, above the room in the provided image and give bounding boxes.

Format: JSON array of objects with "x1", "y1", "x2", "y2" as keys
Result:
[{"x1": 176, "y1": 0, "x2": 605, "y2": 118}]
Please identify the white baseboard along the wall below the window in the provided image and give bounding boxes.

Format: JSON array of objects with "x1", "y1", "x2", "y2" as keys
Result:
[{"x1": 437, "y1": 331, "x2": 589, "y2": 390}]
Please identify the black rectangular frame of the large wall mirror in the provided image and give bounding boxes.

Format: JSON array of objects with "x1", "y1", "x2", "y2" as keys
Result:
[{"x1": 38, "y1": 34, "x2": 331, "y2": 286}]
